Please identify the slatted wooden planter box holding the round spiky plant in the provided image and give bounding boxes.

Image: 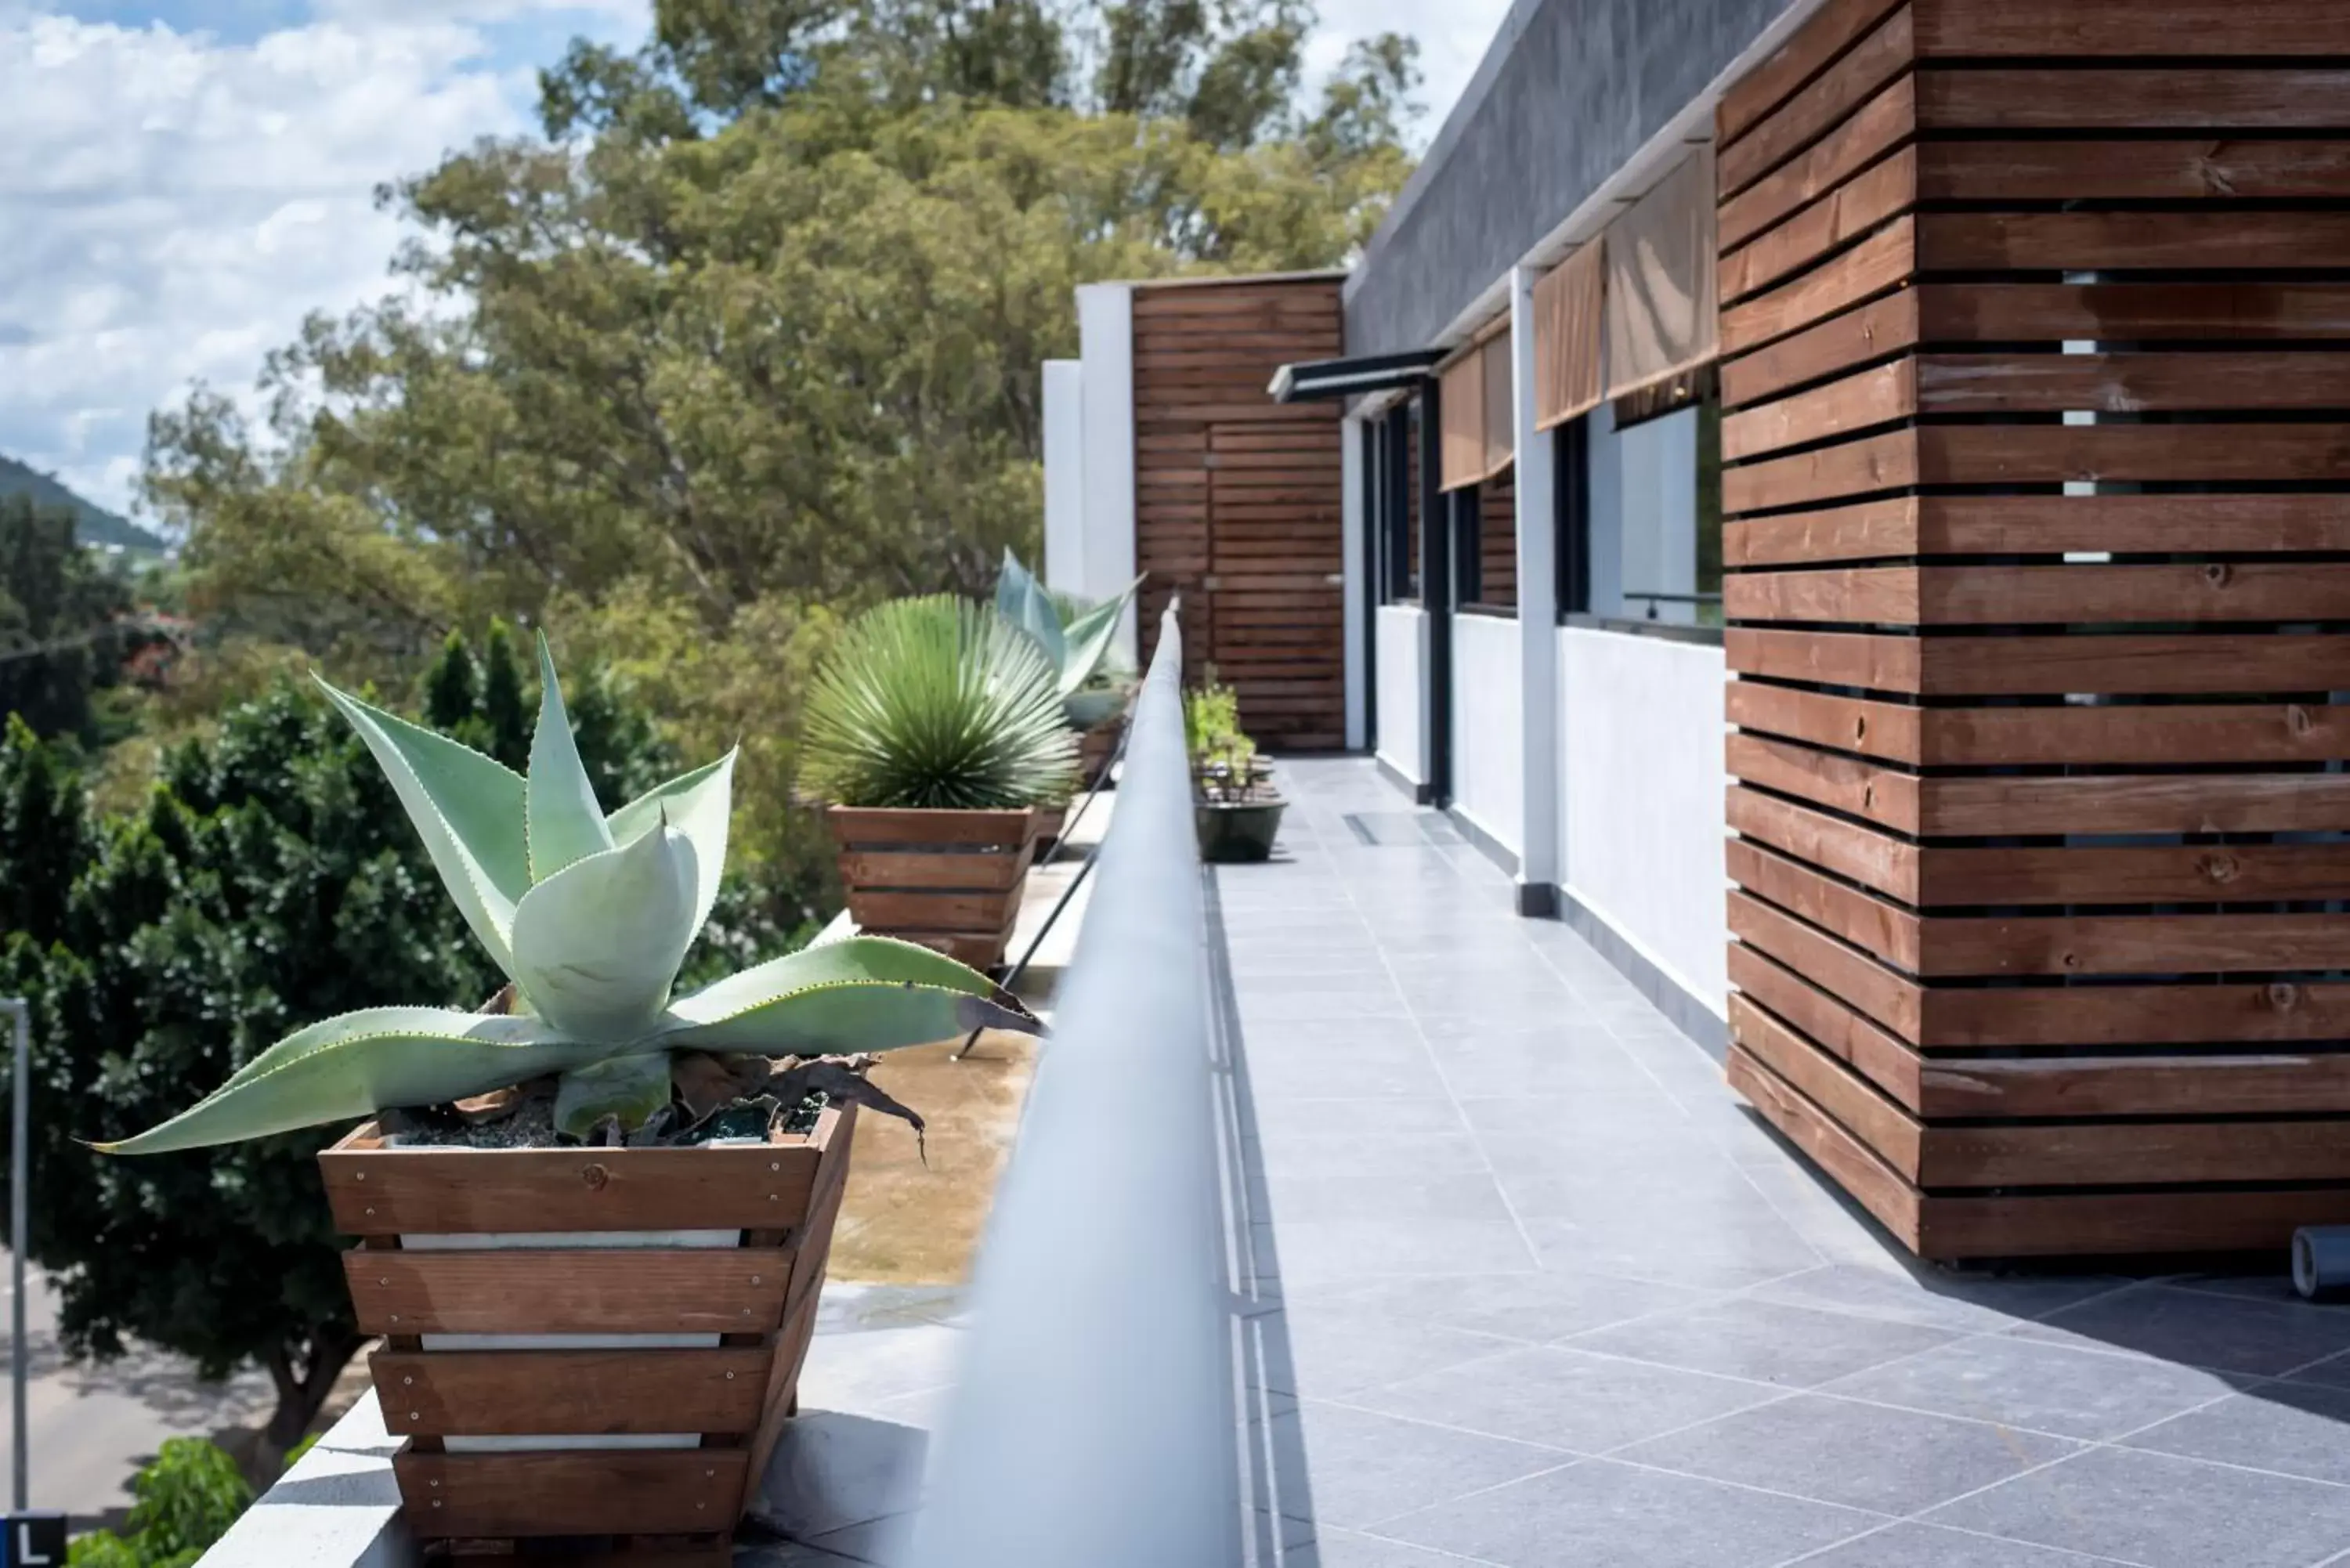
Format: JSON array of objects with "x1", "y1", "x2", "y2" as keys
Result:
[{"x1": 825, "y1": 807, "x2": 1036, "y2": 969}]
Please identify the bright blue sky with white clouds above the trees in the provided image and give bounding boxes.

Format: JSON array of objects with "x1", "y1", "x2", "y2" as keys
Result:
[{"x1": 0, "y1": 0, "x2": 1506, "y2": 526}]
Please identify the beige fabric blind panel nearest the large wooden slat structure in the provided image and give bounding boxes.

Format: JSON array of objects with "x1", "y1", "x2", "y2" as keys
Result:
[{"x1": 1605, "y1": 146, "x2": 1720, "y2": 397}]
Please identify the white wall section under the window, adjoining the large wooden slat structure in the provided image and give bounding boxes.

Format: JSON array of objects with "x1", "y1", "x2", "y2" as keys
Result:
[{"x1": 1558, "y1": 625, "x2": 1730, "y2": 1013}]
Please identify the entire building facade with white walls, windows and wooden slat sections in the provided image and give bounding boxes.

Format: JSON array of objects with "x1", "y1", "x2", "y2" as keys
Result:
[{"x1": 1048, "y1": 0, "x2": 2350, "y2": 1258}]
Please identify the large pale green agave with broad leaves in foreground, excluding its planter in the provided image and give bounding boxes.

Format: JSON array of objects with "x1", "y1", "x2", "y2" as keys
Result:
[{"x1": 99, "y1": 634, "x2": 1036, "y2": 1154}]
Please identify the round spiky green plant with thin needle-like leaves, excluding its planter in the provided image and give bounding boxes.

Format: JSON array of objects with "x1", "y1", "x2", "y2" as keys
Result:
[{"x1": 799, "y1": 594, "x2": 1076, "y2": 811}]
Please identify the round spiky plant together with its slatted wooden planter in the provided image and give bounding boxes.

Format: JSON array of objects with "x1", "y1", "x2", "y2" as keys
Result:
[{"x1": 799, "y1": 594, "x2": 1076, "y2": 969}]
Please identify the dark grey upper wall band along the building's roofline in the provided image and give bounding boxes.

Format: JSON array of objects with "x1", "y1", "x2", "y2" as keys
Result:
[{"x1": 1347, "y1": 0, "x2": 1788, "y2": 355}]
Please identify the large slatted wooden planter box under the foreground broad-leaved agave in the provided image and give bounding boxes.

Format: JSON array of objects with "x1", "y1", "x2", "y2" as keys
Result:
[{"x1": 320, "y1": 1105, "x2": 855, "y2": 1563}]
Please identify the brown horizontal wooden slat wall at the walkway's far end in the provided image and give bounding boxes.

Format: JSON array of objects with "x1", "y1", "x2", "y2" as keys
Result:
[{"x1": 1133, "y1": 277, "x2": 1347, "y2": 750}]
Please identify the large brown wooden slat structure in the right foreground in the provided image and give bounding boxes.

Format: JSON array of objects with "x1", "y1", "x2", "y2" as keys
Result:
[{"x1": 1716, "y1": 0, "x2": 2350, "y2": 1258}]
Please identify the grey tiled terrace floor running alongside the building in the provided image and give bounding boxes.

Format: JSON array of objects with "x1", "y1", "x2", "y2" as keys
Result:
[{"x1": 738, "y1": 759, "x2": 2350, "y2": 1568}]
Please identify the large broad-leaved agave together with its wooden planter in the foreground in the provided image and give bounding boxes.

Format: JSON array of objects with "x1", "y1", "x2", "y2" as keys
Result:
[{"x1": 101, "y1": 637, "x2": 1036, "y2": 1561}]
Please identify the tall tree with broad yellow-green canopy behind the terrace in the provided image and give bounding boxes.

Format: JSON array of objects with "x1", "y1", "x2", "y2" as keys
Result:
[{"x1": 146, "y1": 0, "x2": 1415, "y2": 907}]
